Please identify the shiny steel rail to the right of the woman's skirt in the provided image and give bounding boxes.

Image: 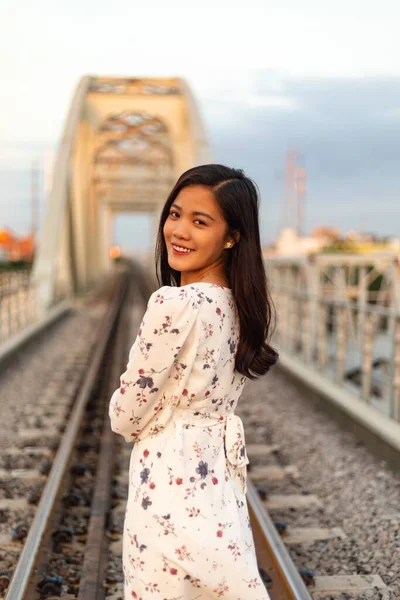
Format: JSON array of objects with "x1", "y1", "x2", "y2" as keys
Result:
[{"x1": 247, "y1": 480, "x2": 312, "y2": 600}]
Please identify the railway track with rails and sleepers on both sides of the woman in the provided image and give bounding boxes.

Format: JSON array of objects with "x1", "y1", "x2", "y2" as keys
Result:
[{"x1": 0, "y1": 274, "x2": 388, "y2": 600}]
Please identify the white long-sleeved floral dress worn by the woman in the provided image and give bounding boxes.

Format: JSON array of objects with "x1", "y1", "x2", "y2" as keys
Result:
[{"x1": 109, "y1": 282, "x2": 269, "y2": 600}]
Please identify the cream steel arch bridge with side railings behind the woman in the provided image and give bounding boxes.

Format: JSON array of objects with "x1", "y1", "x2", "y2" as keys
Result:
[{"x1": 0, "y1": 76, "x2": 400, "y2": 452}]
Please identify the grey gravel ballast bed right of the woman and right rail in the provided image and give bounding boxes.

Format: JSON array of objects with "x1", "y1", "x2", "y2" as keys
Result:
[{"x1": 237, "y1": 369, "x2": 400, "y2": 600}]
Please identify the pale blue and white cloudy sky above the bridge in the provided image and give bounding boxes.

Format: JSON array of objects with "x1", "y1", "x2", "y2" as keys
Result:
[{"x1": 0, "y1": 0, "x2": 400, "y2": 250}]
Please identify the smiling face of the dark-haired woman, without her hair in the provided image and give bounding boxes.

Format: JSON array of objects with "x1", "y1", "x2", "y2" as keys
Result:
[{"x1": 164, "y1": 185, "x2": 228, "y2": 273}]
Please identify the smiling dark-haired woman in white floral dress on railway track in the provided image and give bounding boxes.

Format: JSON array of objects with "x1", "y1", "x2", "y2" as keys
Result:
[{"x1": 110, "y1": 165, "x2": 278, "y2": 600}]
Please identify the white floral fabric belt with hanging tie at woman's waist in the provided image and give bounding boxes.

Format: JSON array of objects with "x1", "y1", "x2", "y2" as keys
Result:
[{"x1": 174, "y1": 408, "x2": 249, "y2": 494}]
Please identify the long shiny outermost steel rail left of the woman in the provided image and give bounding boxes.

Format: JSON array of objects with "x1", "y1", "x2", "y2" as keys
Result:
[{"x1": 6, "y1": 280, "x2": 123, "y2": 600}]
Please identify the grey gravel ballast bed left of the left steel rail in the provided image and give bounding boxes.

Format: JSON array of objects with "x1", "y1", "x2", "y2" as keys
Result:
[{"x1": 0, "y1": 303, "x2": 106, "y2": 451}]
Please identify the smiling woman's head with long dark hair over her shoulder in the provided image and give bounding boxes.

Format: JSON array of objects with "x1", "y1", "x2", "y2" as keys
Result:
[{"x1": 156, "y1": 165, "x2": 278, "y2": 378}]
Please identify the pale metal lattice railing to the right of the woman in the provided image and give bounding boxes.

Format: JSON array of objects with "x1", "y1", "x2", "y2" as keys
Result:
[{"x1": 266, "y1": 255, "x2": 400, "y2": 421}]
